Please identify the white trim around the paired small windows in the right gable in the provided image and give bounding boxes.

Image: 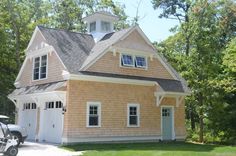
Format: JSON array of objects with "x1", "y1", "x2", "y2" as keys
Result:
[{"x1": 119, "y1": 53, "x2": 148, "y2": 70}]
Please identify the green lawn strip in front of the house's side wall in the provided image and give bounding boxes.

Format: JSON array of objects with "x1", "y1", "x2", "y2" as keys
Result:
[{"x1": 63, "y1": 143, "x2": 236, "y2": 156}]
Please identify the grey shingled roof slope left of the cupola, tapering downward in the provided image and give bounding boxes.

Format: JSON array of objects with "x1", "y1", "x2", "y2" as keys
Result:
[{"x1": 38, "y1": 26, "x2": 95, "y2": 74}]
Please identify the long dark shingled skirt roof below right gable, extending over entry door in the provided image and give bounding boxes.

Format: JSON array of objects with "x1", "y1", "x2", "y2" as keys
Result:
[{"x1": 80, "y1": 71, "x2": 186, "y2": 93}]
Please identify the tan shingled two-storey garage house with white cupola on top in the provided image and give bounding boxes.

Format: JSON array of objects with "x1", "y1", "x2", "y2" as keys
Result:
[{"x1": 9, "y1": 12, "x2": 190, "y2": 144}]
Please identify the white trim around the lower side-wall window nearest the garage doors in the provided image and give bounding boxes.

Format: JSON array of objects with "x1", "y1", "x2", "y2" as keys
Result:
[{"x1": 86, "y1": 101, "x2": 102, "y2": 128}]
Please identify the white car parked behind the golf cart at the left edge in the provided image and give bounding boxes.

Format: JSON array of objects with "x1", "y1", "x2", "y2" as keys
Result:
[{"x1": 0, "y1": 115, "x2": 28, "y2": 145}]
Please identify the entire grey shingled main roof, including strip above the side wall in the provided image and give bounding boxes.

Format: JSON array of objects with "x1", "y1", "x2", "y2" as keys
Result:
[{"x1": 32, "y1": 26, "x2": 190, "y2": 92}]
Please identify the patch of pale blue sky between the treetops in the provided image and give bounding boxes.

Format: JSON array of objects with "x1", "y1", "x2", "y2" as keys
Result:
[{"x1": 114, "y1": 0, "x2": 178, "y2": 42}]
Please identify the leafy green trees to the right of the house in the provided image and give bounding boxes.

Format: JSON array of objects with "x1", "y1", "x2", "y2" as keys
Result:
[{"x1": 155, "y1": 0, "x2": 236, "y2": 142}]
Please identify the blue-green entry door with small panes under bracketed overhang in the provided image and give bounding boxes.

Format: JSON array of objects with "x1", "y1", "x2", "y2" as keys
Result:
[{"x1": 162, "y1": 107, "x2": 173, "y2": 140}]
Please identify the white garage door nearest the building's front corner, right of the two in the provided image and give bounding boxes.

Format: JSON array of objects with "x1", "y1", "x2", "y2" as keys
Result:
[{"x1": 43, "y1": 101, "x2": 63, "y2": 143}]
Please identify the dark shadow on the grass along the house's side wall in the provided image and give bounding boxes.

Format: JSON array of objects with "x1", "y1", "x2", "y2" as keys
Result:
[{"x1": 62, "y1": 142, "x2": 219, "y2": 152}]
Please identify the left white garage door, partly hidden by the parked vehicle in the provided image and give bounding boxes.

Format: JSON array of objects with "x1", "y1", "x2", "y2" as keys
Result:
[{"x1": 19, "y1": 103, "x2": 37, "y2": 140}]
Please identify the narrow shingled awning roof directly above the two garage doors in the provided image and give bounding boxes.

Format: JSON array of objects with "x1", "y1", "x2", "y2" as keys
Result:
[{"x1": 8, "y1": 81, "x2": 66, "y2": 97}]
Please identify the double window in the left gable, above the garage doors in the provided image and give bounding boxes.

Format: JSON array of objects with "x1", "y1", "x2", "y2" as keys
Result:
[{"x1": 33, "y1": 55, "x2": 47, "y2": 80}]
